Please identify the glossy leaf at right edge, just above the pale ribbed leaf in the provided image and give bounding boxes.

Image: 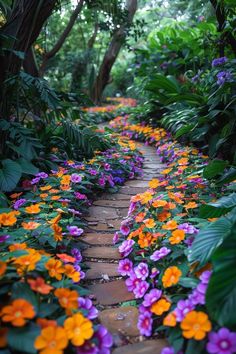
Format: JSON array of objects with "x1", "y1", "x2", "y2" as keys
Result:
[{"x1": 199, "y1": 193, "x2": 236, "y2": 218}]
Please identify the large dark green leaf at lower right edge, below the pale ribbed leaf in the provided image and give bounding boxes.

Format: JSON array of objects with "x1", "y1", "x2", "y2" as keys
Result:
[{"x1": 206, "y1": 227, "x2": 236, "y2": 329}]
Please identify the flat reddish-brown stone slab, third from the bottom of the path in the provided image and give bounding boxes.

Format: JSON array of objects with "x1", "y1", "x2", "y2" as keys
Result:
[{"x1": 88, "y1": 280, "x2": 134, "y2": 305}]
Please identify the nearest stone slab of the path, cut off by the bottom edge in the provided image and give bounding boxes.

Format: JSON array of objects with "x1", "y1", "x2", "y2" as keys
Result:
[{"x1": 112, "y1": 339, "x2": 168, "y2": 354}]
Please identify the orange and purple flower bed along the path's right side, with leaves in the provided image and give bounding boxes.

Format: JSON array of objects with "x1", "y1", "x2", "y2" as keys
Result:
[{"x1": 111, "y1": 116, "x2": 236, "y2": 354}]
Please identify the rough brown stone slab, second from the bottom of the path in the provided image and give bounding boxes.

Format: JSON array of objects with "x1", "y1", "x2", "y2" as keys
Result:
[{"x1": 98, "y1": 306, "x2": 139, "y2": 337}]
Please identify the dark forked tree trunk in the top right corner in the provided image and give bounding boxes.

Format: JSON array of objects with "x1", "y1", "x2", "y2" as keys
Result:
[{"x1": 210, "y1": 0, "x2": 236, "y2": 57}]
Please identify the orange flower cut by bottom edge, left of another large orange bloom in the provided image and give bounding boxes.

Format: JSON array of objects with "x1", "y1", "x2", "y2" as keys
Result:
[{"x1": 34, "y1": 326, "x2": 68, "y2": 354}]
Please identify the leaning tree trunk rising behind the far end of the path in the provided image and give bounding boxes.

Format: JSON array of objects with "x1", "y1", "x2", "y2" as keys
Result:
[{"x1": 91, "y1": 0, "x2": 137, "y2": 104}]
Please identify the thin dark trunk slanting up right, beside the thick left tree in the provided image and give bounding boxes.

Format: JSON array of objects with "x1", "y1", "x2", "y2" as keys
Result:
[{"x1": 39, "y1": 0, "x2": 84, "y2": 77}]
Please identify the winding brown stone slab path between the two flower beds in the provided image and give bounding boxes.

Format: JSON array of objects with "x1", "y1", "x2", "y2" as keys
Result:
[{"x1": 83, "y1": 145, "x2": 167, "y2": 354}]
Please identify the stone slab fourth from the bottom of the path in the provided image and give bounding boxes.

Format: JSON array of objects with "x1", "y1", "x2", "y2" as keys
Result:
[{"x1": 86, "y1": 262, "x2": 119, "y2": 280}]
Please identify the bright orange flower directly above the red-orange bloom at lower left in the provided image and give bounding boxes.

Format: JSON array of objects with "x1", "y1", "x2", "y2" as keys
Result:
[{"x1": 14, "y1": 249, "x2": 41, "y2": 275}]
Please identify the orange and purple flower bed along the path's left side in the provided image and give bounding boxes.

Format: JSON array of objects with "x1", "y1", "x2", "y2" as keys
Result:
[{"x1": 0, "y1": 131, "x2": 142, "y2": 354}]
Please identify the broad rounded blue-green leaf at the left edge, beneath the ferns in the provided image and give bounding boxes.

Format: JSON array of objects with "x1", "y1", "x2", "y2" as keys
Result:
[{"x1": 0, "y1": 159, "x2": 22, "y2": 192}]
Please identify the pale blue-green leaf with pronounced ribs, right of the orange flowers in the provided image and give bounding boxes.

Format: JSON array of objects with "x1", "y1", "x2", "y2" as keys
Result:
[{"x1": 188, "y1": 217, "x2": 232, "y2": 266}]
